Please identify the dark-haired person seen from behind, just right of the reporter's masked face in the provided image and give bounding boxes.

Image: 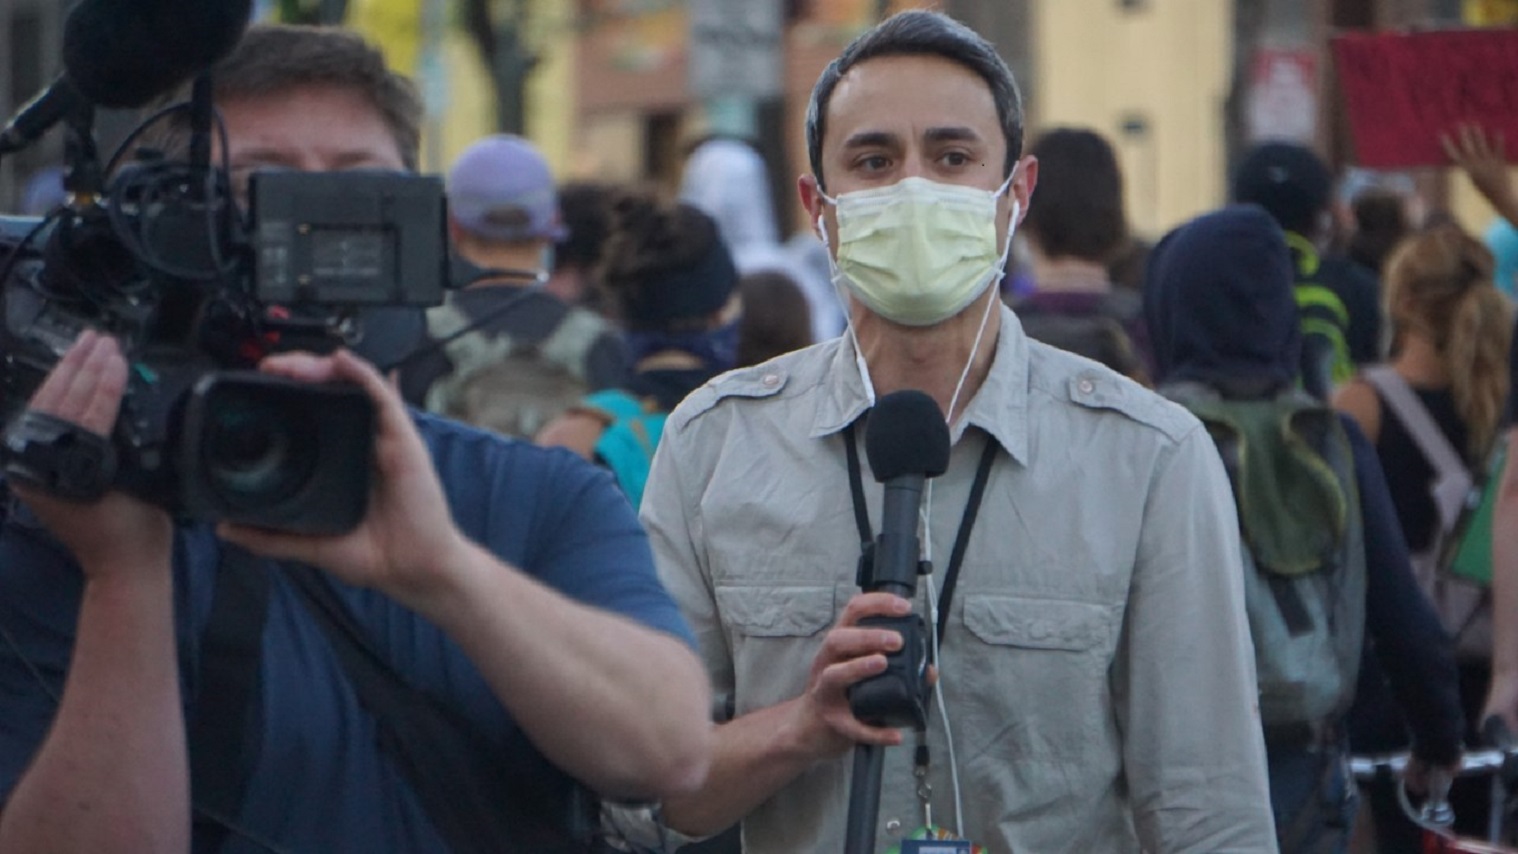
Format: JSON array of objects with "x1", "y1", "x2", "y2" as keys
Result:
[{"x1": 1013, "y1": 127, "x2": 1154, "y2": 382}]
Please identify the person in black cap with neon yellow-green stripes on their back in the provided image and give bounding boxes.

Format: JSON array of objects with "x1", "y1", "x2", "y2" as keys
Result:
[{"x1": 1233, "y1": 141, "x2": 1381, "y2": 400}]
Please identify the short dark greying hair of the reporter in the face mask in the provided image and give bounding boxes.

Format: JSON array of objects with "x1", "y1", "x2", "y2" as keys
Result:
[{"x1": 806, "y1": 9, "x2": 1023, "y2": 185}]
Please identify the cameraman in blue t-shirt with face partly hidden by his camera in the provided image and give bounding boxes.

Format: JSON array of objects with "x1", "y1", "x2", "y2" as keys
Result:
[{"x1": 0, "y1": 27, "x2": 709, "y2": 854}]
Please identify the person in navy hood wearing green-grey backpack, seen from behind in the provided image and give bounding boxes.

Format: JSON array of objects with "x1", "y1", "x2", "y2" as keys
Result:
[{"x1": 1145, "y1": 206, "x2": 1462, "y2": 854}]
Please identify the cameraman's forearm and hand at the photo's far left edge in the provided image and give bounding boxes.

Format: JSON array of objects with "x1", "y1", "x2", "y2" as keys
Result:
[{"x1": 0, "y1": 332, "x2": 190, "y2": 854}]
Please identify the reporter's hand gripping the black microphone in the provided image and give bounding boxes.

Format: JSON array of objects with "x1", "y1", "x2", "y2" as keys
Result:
[{"x1": 791, "y1": 593, "x2": 912, "y2": 757}]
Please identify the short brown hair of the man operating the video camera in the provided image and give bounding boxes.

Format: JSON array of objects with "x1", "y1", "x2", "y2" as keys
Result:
[{"x1": 144, "y1": 24, "x2": 422, "y2": 171}]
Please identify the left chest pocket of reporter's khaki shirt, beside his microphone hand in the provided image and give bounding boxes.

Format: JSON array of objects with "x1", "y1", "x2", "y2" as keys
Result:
[{"x1": 716, "y1": 586, "x2": 839, "y2": 714}]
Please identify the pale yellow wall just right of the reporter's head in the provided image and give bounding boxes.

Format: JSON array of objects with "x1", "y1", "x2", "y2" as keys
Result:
[{"x1": 1028, "y1": 0, "x2": 1231, "y2": 237}]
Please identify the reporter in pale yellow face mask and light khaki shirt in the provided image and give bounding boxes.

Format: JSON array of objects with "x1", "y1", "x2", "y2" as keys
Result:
[{"x1": 642, "y1": 12, "x2": 1275, "y2": 854}]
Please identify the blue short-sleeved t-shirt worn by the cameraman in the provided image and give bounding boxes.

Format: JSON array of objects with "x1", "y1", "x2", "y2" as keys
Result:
[{"x1": 0, "y1": 416, "x2": 694, "y2": 852}]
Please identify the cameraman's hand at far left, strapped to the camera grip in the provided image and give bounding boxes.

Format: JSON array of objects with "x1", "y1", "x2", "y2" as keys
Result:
[{"x1": 12, "y1": 329, "x2": 173, "y2": 578}]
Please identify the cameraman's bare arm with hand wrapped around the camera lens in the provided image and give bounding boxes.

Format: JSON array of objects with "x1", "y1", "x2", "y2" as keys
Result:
[{"x1": 222, "y1": 353, "x2": 710, "y2": 798}]
